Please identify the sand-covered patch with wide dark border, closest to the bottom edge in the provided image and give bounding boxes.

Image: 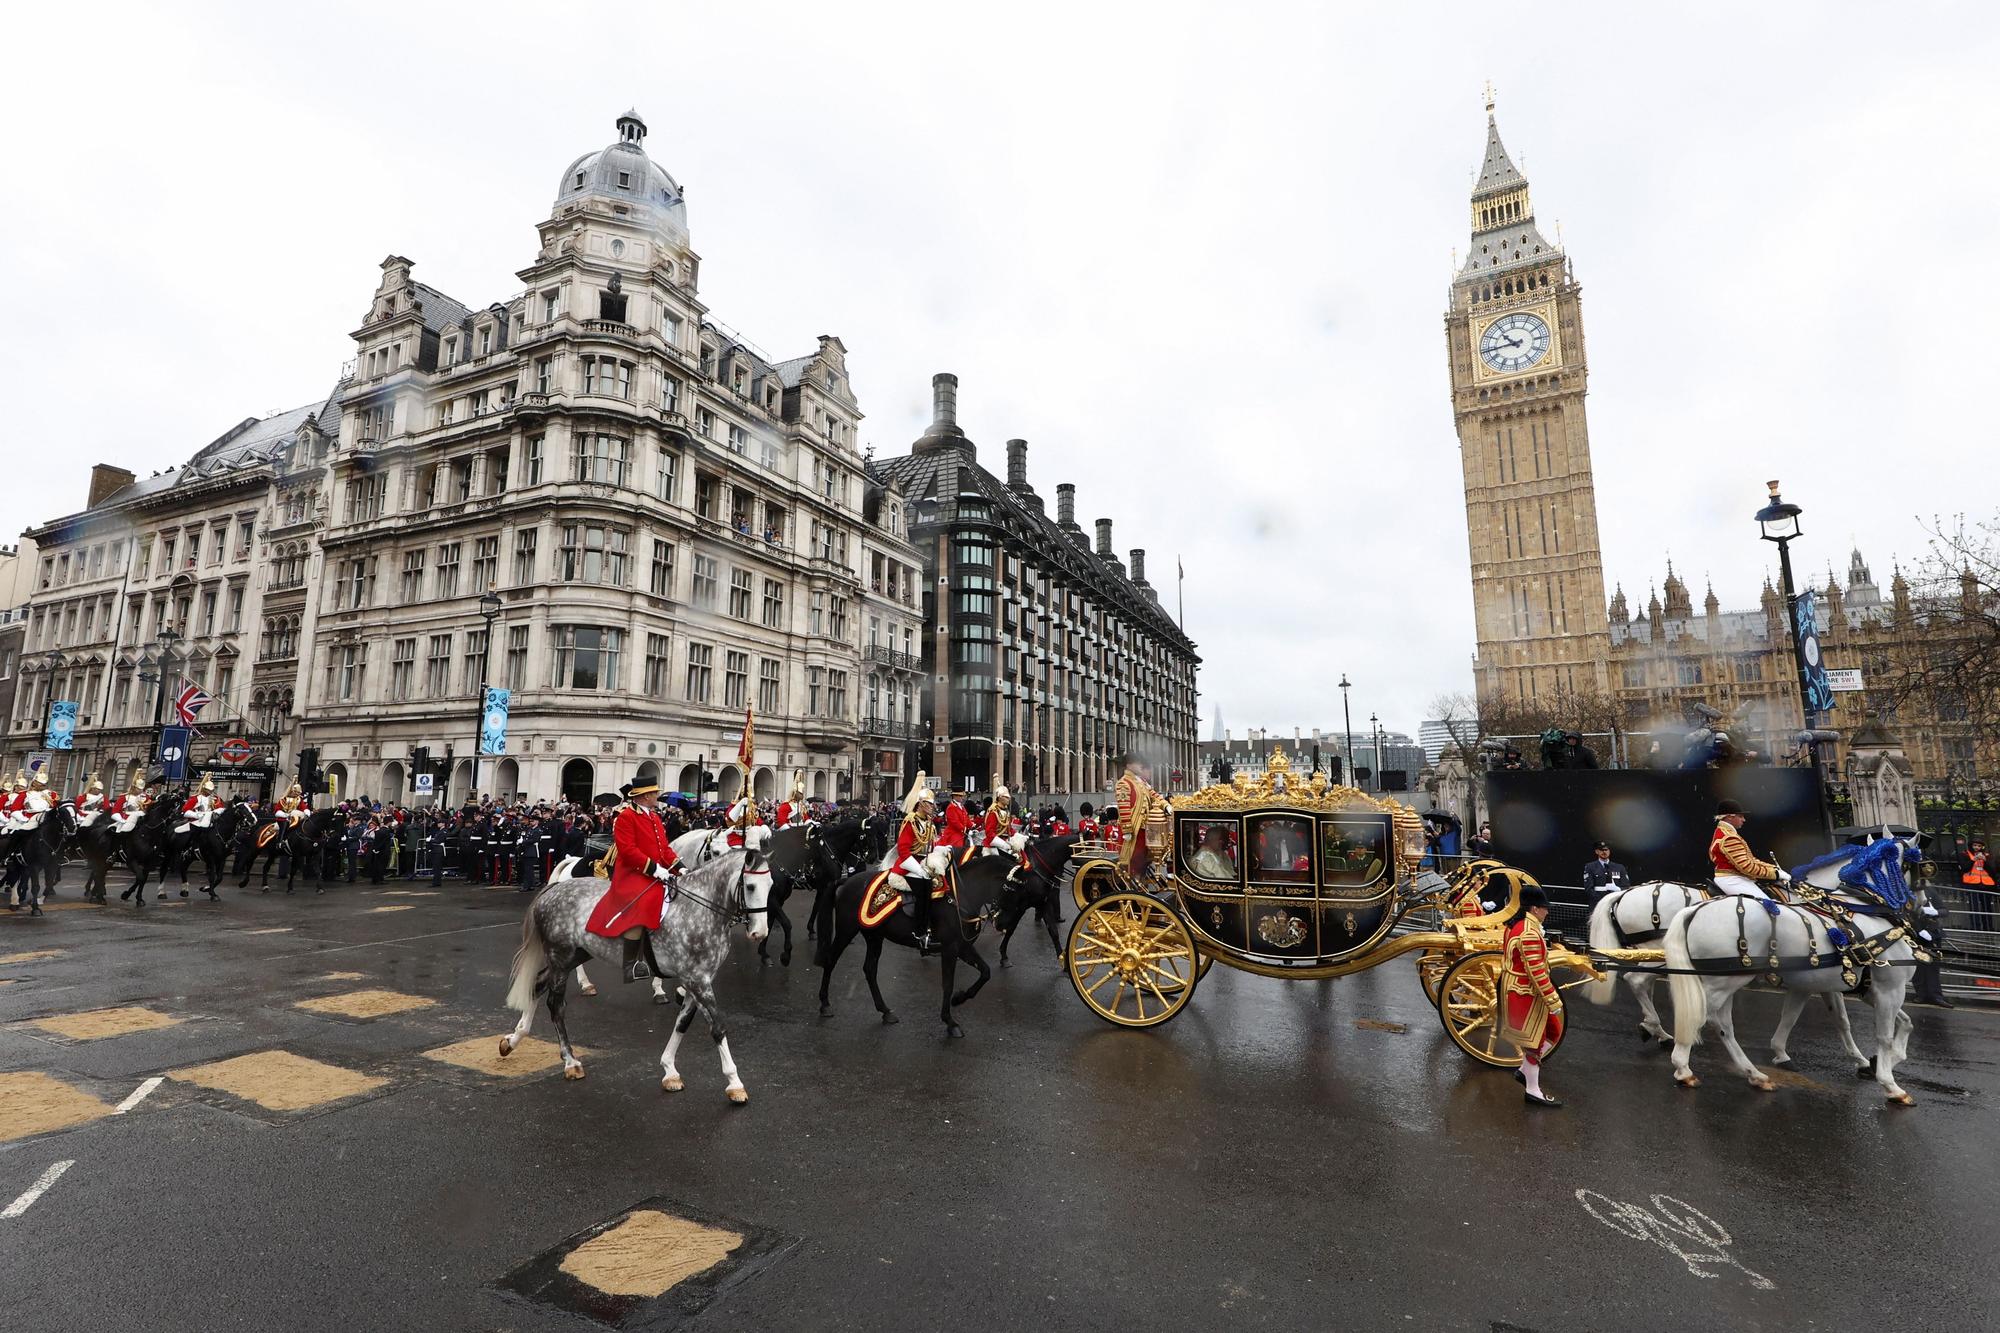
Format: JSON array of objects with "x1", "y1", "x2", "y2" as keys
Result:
[{"x1": 498, "y1": 1199, "x2": 794, "y2": 1329}]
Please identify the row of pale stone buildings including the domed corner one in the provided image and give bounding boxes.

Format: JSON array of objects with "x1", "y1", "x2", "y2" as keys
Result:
[{"x1": 8, "y1": 114, "x2": 920, "y2": 801}]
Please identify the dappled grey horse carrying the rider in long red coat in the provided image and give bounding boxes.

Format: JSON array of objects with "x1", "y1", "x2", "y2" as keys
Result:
[{"x1": 500, "y1": 849, "x2": 770, "y2": 1105}]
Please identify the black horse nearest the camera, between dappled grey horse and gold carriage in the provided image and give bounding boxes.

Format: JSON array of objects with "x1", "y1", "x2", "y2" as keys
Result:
[{"x1": 814, "y1": 853, "x2": 1010, "y2": 1037}]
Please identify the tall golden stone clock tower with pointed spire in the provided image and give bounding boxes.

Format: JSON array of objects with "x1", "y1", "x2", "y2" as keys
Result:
[{"x1": 1444, "y1": 96, "x2": 1610, "y2": 705}]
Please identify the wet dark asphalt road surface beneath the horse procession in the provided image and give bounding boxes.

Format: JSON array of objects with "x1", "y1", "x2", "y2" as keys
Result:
[{"x1": 0, "y1": 883, "x2": 2000, "y2": 1333}]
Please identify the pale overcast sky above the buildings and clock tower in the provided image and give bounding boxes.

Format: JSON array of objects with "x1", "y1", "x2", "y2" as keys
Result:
[{"x1": 0, "y1": 0, "x2": 2000, "y2": 737}]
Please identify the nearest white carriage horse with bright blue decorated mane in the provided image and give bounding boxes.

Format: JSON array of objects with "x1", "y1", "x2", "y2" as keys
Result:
[{"x1": 1664, "y1": 837, "x2": 1928, "y2": 1105}]
